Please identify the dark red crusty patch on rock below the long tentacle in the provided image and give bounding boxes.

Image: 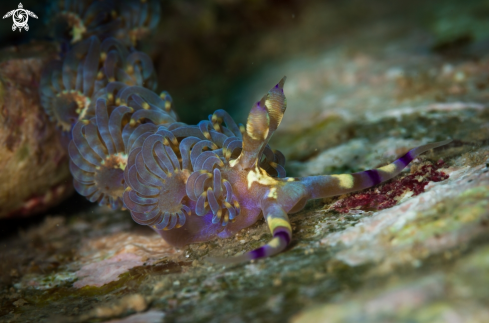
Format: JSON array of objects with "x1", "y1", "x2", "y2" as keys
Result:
[{"x1": 329, "y1": 159, "x2": 448, "y2": 213}]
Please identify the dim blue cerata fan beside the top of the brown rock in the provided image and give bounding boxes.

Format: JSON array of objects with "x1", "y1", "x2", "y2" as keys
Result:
[{"x1": 39, "y1": 36, "x2": 157, "y2": 132}]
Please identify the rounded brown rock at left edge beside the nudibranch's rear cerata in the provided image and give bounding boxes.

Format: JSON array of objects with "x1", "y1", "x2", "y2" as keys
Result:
[{"x1": 0, "y1": 45, "x2": 73, "y2": 218}]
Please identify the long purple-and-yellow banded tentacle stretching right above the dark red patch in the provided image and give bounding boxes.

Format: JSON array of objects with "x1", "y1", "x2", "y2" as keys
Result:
[{"x1": 299, "y1": 139, "x2": 452, "y2": 199}]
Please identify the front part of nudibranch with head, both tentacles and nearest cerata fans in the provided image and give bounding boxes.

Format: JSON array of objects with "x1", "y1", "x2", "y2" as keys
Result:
[{"x1": 123, "y1": 77, "x2": 450, "y2": 263}]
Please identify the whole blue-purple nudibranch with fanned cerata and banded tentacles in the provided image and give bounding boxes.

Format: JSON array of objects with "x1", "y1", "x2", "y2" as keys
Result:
[{"x1": 49, "y1": 0, "x2": 450, "y2": 263}]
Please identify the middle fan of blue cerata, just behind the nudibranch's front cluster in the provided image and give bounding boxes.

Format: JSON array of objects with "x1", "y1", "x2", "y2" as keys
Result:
[{"x1": 68, "y1": 82, "x2": 176, "y2": 209}]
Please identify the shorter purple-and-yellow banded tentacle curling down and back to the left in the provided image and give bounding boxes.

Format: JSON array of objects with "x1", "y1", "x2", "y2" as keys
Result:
[{"x1": 208, "y1": 200, "x2": 292, "y2": 265}]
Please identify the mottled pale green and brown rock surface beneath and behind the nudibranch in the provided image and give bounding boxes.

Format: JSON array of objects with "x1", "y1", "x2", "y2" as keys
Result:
[{"x1": 0, "y1": 1, "x2": 489, "y2": 323}]
